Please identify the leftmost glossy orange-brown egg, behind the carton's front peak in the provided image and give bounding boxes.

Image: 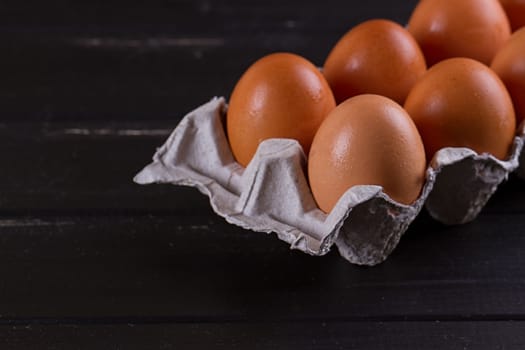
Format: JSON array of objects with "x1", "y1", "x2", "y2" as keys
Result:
[{"x1": 226, "y1": 53, "x2": 335, "y2": 166}]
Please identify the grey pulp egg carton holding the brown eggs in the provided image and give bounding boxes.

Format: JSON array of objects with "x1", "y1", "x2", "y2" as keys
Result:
[{"x1": 134, "y1": 98, "x2": 523, "y2": 265}]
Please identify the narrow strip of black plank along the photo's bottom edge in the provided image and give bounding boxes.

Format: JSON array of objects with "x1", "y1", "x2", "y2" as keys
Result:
[{"x1": 0, "y1": 321, "x2": 525, "y2": 350}]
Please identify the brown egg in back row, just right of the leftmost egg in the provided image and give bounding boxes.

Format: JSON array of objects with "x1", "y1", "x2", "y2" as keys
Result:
[{"x1": 323, "y1": 19, "x2": 426, "y2": 103}]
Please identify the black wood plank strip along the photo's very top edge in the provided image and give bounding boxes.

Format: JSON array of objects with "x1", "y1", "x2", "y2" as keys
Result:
[{"x1": 0, "y1": 0, "x2": 417, "y2": 30}]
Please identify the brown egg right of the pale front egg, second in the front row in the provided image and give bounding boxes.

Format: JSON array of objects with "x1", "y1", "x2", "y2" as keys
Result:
[{"x1": 405, "y1": 58, "x2": 516, "y2": 159}]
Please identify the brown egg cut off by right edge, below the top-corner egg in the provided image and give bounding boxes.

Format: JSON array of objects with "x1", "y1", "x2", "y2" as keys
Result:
[{"x1": 491, "y1": 28, "x2": 525, "y2": 125}]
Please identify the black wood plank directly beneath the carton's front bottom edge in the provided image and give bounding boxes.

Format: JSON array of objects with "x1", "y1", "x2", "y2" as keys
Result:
[{"x1": 0, "y1": 214, "x2": 525, "y2": 323}]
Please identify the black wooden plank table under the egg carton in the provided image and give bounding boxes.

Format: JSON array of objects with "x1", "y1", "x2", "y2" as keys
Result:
[{"x1": 0, "y1": 0, "x2": 525, "y2": 349}]
